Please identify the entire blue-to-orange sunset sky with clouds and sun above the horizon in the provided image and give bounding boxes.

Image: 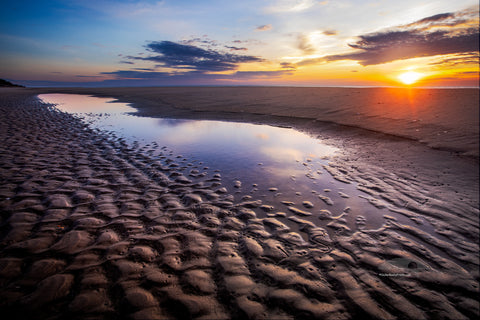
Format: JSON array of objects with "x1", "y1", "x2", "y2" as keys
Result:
[{"x1": 0, "y1": 0, "x2": 479, "y2": 87}]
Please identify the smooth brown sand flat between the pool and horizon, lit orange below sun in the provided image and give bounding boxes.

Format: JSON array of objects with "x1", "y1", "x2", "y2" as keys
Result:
[{"x1": 29, "y1": 87, "x2": 479, "y2": 157}]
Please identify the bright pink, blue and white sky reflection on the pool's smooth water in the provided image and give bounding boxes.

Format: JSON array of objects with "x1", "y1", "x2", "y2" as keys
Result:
[{"x1": 39, "y1": 94, "x2": 342, "y2": 195}]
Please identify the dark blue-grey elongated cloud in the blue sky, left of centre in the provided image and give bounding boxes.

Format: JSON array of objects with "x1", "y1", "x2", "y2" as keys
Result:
[{"x1": 130, "y1": 41, "x2": 263, "y2": 72}]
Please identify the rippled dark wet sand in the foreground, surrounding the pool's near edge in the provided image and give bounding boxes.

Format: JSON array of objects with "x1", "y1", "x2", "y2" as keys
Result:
[{"x1": 0, "y1": 89, "x2": 479, "y2": 319}]
